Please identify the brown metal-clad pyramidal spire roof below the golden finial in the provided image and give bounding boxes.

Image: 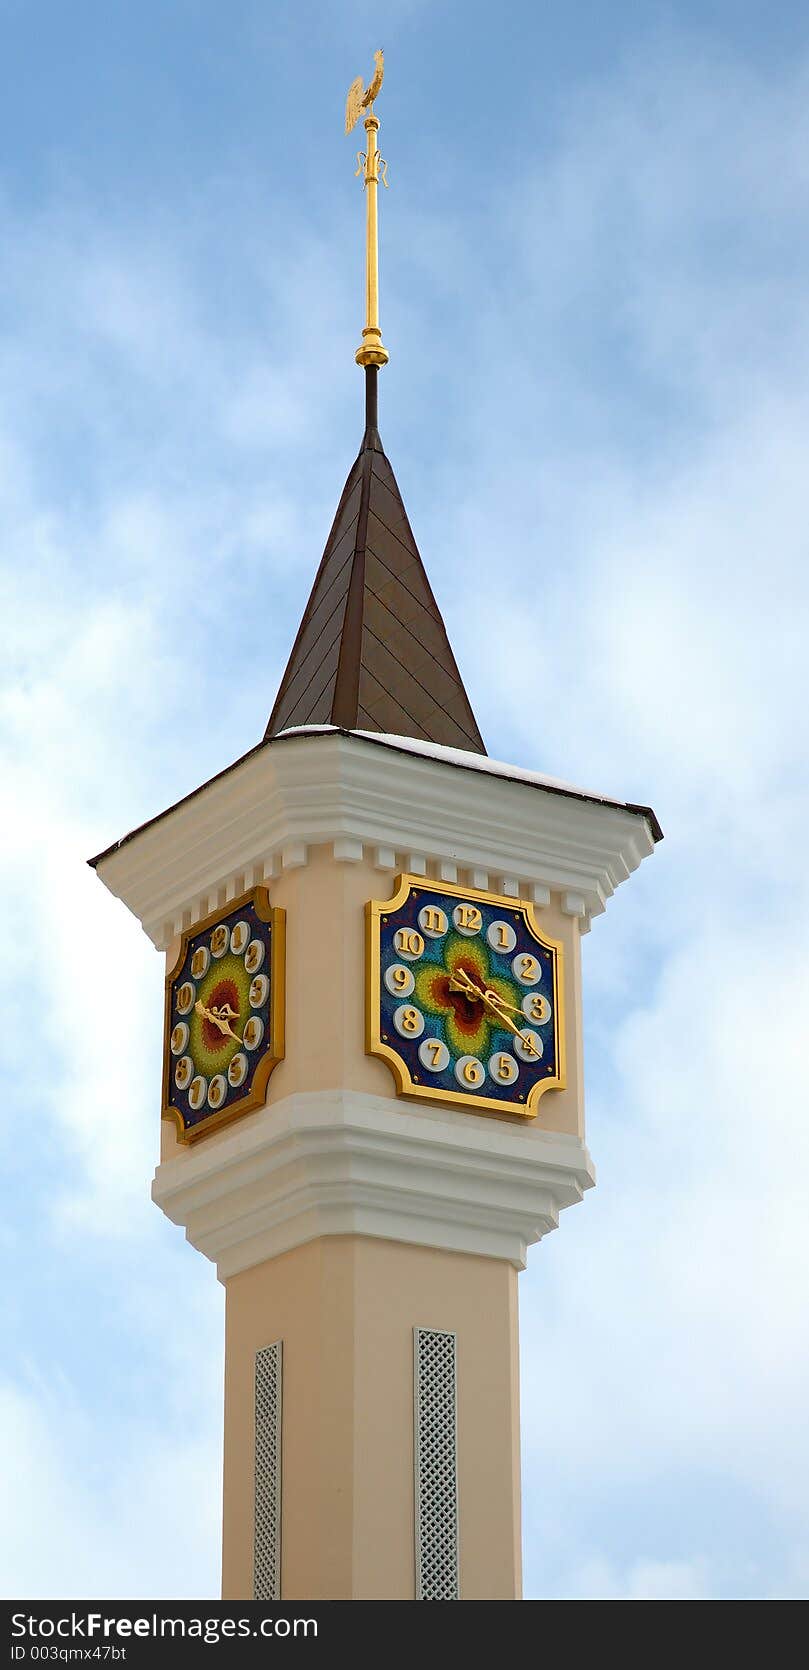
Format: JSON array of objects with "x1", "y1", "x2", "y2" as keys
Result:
[{"x1": 266, "y1": 366, "x2": 486, "y2": 753}]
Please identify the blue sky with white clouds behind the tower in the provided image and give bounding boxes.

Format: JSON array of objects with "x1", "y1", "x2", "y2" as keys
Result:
[{"x1": 0, "y1": 0, "x2": 809, "y2": 1598}]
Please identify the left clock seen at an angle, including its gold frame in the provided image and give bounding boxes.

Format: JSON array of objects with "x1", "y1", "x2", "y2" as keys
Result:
[{"x1": 164, "y1": 887, "x2": 284, "y2": 1141}]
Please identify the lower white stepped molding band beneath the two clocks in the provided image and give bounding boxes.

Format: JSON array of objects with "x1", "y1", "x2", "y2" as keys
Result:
[{"x1": 152, "y1": 1091, "x2": 595, "y2": 1281}]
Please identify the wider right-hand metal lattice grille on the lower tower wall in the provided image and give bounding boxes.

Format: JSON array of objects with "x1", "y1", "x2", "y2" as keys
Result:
[{"x1": 413, "y1": 1328, "x2": 460, "y2": 1600}]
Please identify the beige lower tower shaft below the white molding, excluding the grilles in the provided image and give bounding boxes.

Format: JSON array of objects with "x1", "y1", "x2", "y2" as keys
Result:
[{"x1": 222, "y1": 1236, "x2": 520, "y2": 1600}]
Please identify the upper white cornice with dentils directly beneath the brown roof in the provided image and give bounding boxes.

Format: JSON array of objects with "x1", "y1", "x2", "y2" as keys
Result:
[{"x1": 97, "y1": 731, "x2": 654, "y2": 947}]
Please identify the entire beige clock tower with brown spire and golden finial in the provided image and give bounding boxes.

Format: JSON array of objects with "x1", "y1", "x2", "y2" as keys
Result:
[{"x1": 92, "y1": 53, "x2": 660, "y2": 1600}]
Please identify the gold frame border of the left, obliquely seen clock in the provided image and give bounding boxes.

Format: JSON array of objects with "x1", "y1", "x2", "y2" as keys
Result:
[{"x1": 160, "y1": 887, "x2": 286, "y2": 1142}]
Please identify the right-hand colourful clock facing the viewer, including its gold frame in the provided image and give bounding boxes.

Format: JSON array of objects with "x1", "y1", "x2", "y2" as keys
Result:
[{"x1": 366, "y1": 875, "x2": 565, "y2": 1117}]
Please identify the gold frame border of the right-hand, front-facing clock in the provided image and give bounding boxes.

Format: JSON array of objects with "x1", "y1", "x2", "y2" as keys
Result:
[{"x1": 364, "y1": 872, "x2": 567, "y2": 1121}]
